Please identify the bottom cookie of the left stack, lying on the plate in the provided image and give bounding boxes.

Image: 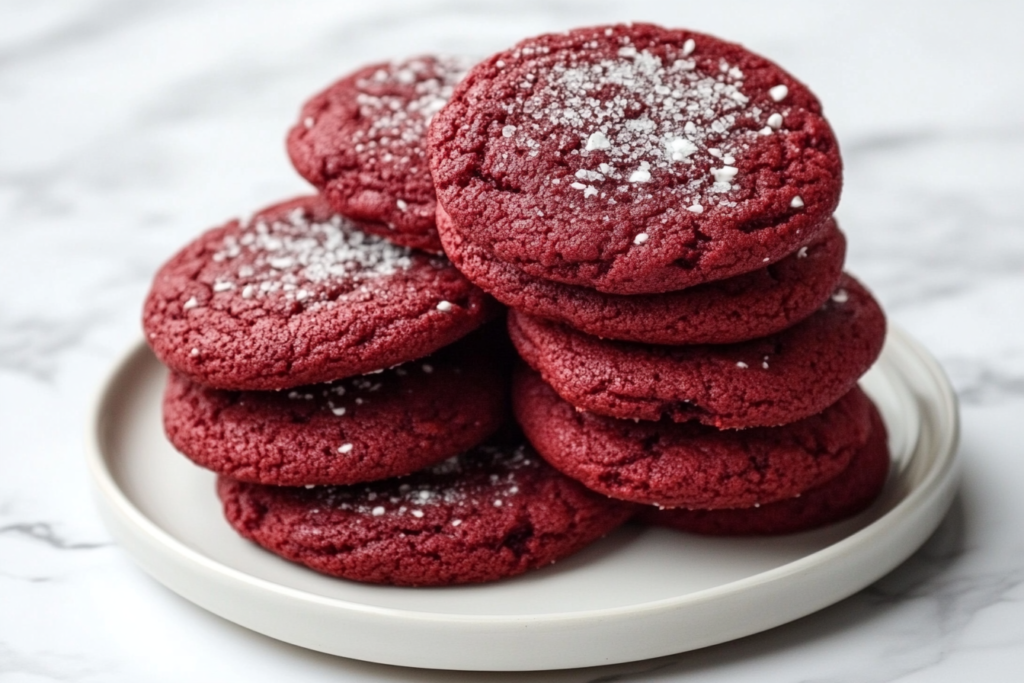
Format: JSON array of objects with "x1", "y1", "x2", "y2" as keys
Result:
[{"x1": 217, "y1": 440, "x2": 634, "y2": 586}]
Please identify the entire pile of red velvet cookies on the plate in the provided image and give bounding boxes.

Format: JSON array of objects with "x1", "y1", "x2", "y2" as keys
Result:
[{"x1": 144, "y1": 25, "x2": 888, "y2": 585}]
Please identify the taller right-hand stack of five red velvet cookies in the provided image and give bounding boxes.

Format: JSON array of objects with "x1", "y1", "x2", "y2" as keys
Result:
[{"x1": 429, "y1": 25, "x2": 888, "y2": 532}]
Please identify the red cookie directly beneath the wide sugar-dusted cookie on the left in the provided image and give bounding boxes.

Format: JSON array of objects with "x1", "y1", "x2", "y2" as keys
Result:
[{"x1": 163, "y1": 335, "x2": 508, "y2": 486}]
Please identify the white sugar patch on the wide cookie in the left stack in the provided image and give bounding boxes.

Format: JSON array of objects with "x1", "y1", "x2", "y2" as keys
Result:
[{"x1": 208, "y1": 209, "x2": 423, "y2": 307}]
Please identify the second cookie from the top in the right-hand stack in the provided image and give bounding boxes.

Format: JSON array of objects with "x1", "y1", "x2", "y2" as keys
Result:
[{"x1": 437, "y1": 209, "x2": 846, "y2": 344}]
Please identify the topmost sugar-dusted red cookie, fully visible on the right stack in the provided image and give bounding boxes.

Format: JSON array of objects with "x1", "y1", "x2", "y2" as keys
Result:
[{"x1": 428, "y1": 24, "x2": 842, "y2": 294}]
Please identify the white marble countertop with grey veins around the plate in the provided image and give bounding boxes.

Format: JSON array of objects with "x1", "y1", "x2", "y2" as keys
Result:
[{"x1": 0, "y1": 0, "x2": 1024, "y2": 683}]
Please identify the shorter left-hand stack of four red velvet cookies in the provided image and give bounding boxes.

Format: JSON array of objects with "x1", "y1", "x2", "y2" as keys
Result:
[{"x1": 143, "y1": 59, "x2": 632, "y2": 586}]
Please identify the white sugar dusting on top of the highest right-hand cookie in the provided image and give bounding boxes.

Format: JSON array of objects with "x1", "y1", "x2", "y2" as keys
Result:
[{"x1": 502, "y1": 34, "x2": 782, "y2": 206}]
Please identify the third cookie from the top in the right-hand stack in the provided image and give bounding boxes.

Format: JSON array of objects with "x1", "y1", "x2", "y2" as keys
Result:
[{"x1": 509, "y1": 275, "x2": 886, "y2": 429}]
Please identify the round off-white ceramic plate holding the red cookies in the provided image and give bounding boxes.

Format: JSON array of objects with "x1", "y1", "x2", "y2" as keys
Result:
[{"x1": 87, "y1": 331, "x2": 957, "y2": 671}]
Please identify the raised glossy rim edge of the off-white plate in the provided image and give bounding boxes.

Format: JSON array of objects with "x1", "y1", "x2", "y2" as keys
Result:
[{"x1": 85, "y1": 326, "x2": 959, "y2": 671}]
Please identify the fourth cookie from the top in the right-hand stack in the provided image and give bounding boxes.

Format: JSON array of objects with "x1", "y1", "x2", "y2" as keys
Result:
[{"x1": 512, "y1": 367, "x2": 870, "y2": 510}]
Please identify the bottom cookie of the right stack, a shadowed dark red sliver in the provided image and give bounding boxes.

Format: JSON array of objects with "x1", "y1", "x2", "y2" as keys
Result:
[{"x1": 636, "y1": 403, "x2": 889, "y2": 536}]
